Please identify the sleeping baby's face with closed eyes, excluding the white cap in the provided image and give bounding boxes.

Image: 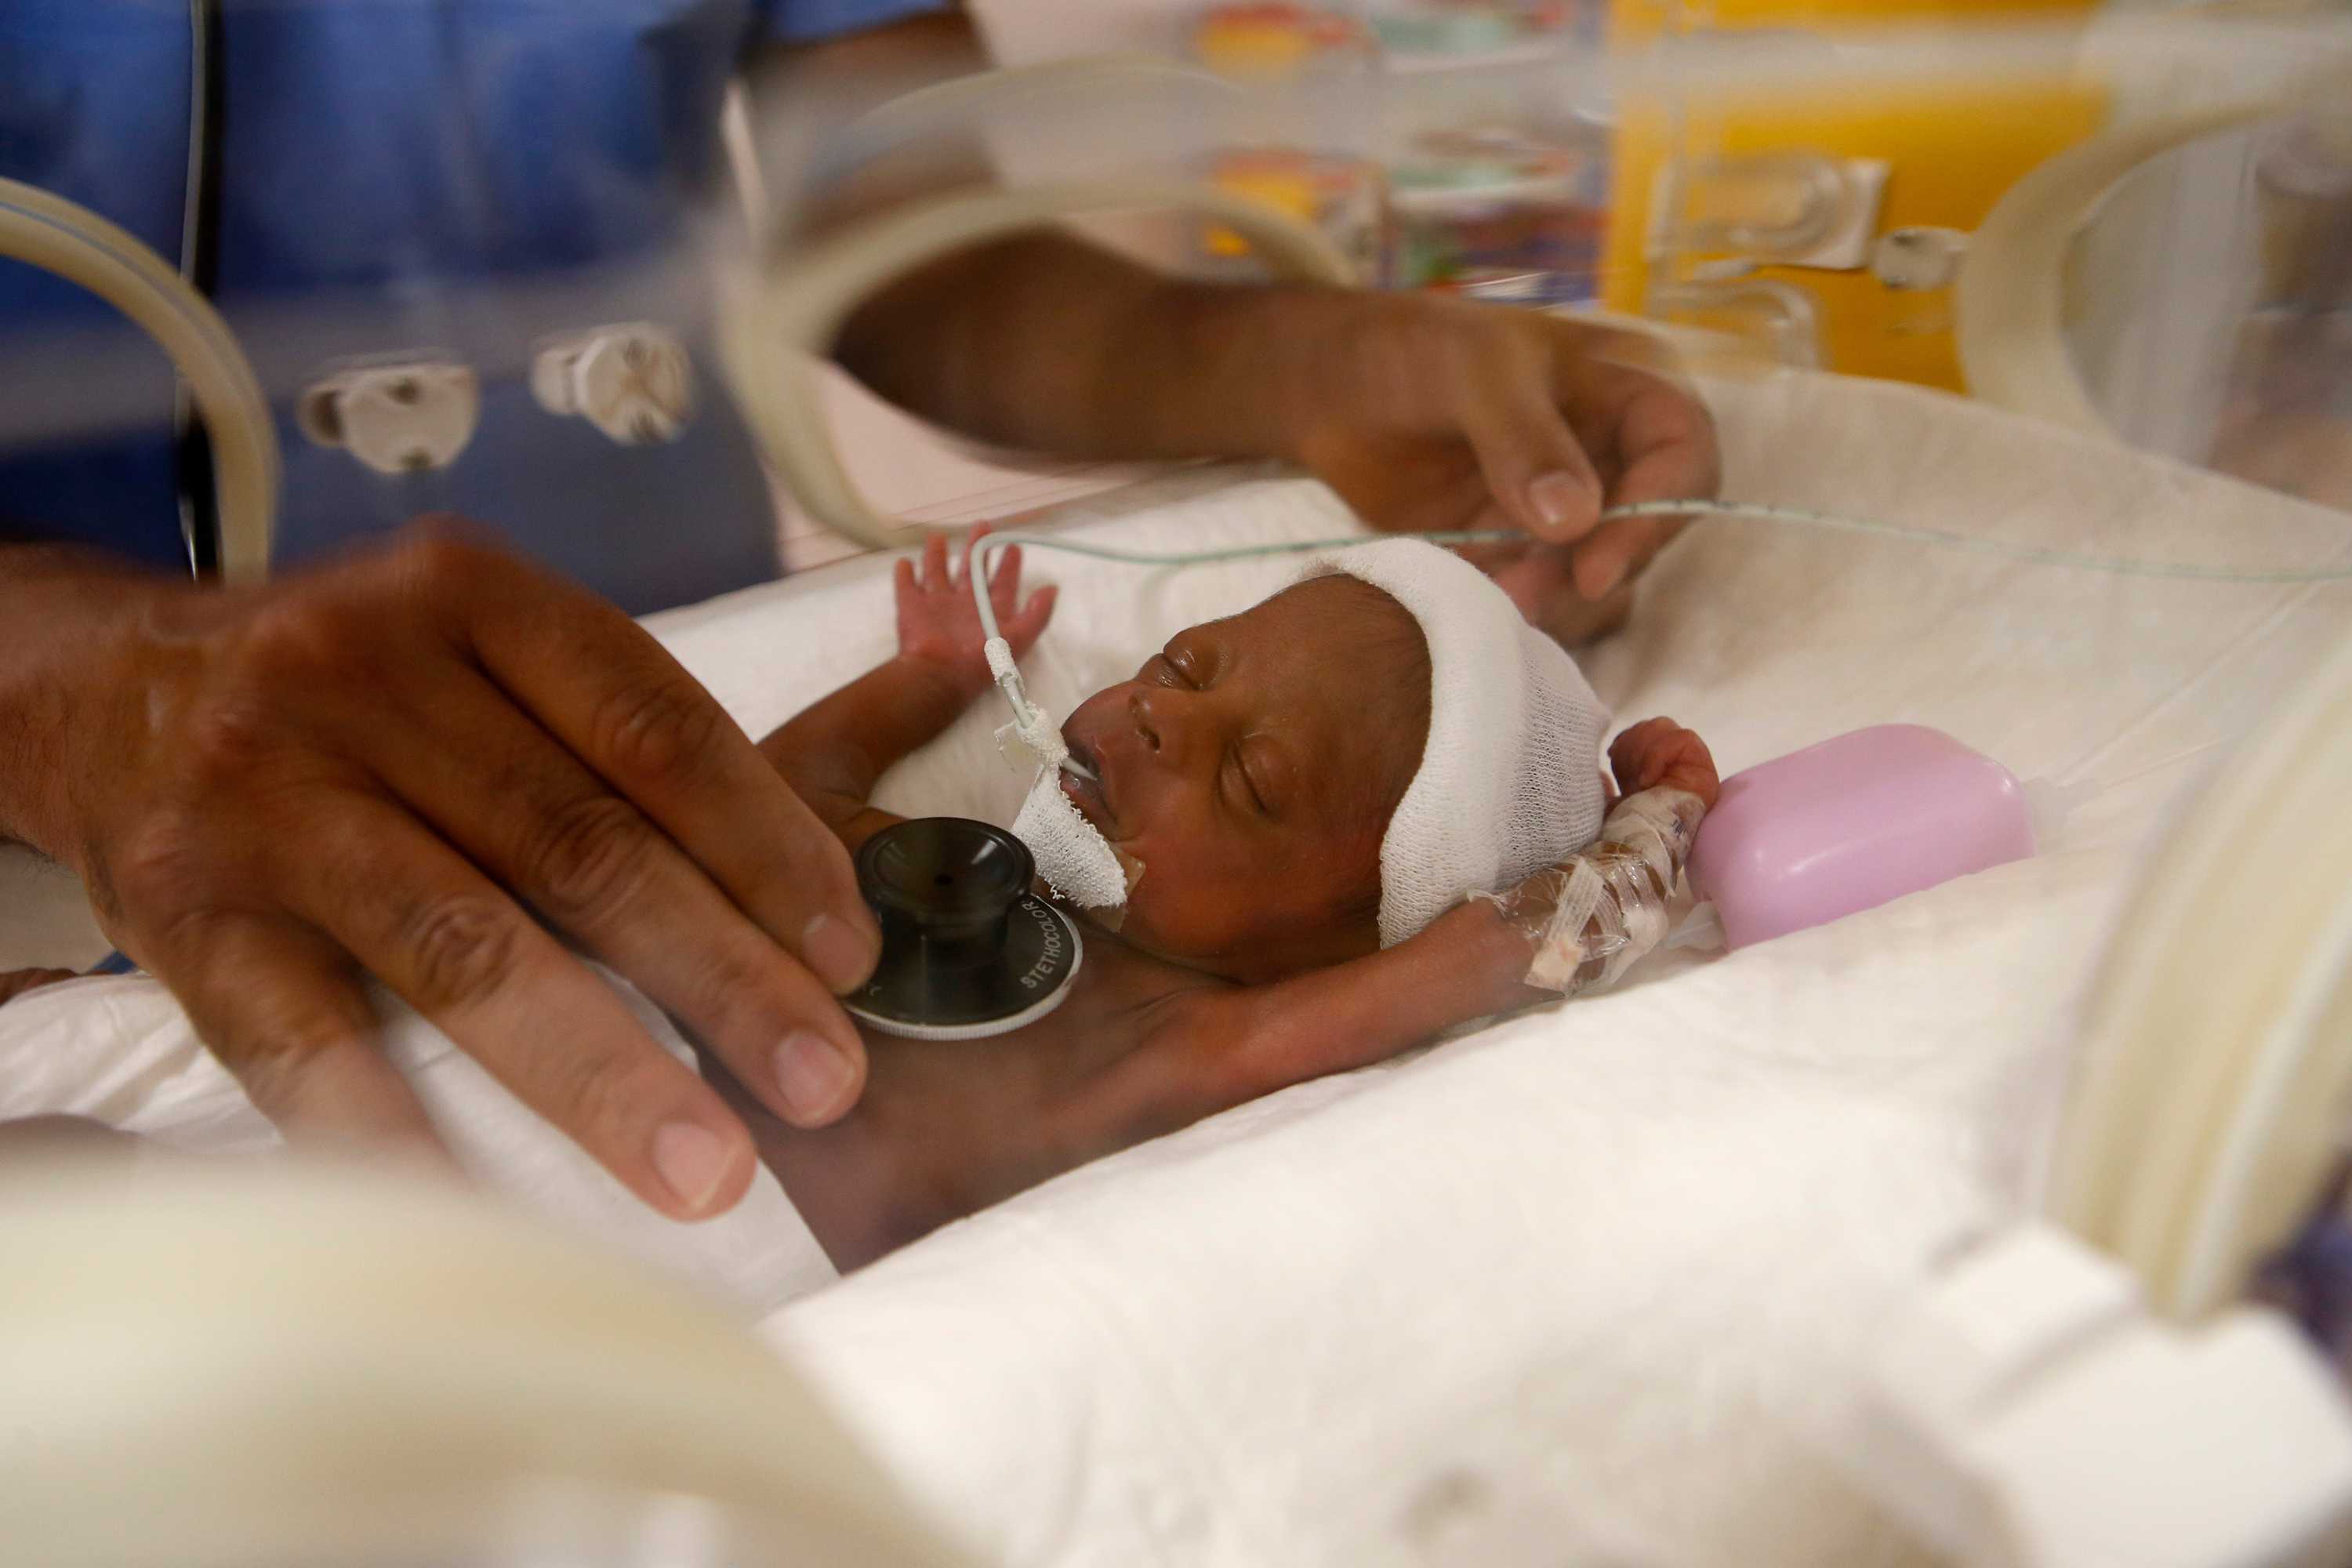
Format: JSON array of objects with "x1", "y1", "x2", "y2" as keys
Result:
[{"x1": 1061, "y1": 576, "x2": 1430, "y2": 980}]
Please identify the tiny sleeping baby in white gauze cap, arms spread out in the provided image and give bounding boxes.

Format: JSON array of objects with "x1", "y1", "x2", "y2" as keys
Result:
[{"x1": 0, "y1": 539, "x2": 1717, "y2": 1298}]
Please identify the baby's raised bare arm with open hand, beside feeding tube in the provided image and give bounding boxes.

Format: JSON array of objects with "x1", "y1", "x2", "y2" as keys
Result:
[{"x1": 760, "y1": 529, "x2": 1054, "y2": 848}]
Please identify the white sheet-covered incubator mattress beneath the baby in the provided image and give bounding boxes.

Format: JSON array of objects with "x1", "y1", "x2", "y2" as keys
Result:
[{"x1": 0, "y1": 376, "x2": 2352, "y2": 1566}]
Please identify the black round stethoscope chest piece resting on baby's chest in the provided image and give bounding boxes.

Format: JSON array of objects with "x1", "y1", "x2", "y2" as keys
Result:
[{"x1": 844, "y1": 815, "x2": 1084, "y2": 1039}]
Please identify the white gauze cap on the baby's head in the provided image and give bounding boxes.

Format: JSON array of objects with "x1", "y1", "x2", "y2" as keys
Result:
[{"x1": 1303, "y1": 539, "x2": 1609, "y2": 947}]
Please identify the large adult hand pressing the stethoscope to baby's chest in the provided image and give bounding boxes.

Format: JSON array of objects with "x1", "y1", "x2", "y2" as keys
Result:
[{"x1": 0, "y1": 524, "x2": 880, "y2": 1218}]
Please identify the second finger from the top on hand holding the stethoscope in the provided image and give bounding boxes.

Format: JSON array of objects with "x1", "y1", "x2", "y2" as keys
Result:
[{"x1": 372, "y1": 673, "x2": 866, "y2": 1126}]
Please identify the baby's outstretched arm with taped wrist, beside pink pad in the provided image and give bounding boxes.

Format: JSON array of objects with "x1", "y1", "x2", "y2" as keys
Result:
[{"x1": 1091, "y1": 720, "x2": 1717, "y2": 1131}]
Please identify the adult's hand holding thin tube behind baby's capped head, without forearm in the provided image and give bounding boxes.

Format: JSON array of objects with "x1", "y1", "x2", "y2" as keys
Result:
[{"x1": 1284, "y1": 294, "x2": 1722, "y2": 642}]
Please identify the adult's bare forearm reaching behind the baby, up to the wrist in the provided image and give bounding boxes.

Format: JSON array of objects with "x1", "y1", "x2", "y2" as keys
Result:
[{"x1": 835, "y1": 233, "x2": 1350, "y2": 459}]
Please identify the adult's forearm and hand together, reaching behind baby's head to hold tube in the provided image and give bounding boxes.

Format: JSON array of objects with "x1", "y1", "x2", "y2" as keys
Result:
[{"x1": 835, "y1": 235, "x2": 1719, "y2": 642}]
